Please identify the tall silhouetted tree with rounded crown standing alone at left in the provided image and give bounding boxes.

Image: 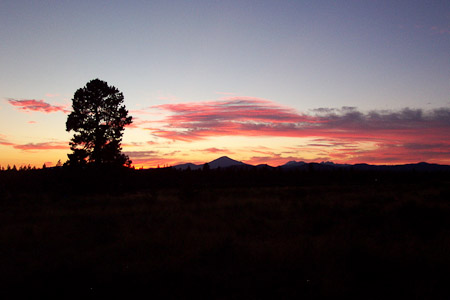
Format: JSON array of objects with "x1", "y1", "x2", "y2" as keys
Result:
[{"x1": 66, "y1": 79, "x2": 132, "y2": 166}]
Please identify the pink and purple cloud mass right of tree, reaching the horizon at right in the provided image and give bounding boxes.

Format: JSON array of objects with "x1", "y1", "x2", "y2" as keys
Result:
[{"x1": 148, "y1": 97, "x2": 450, "y2": 163}]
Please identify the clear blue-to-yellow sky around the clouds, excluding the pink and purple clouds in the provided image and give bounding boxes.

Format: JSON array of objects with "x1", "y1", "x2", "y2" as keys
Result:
[{"x1": 0, "y1": 1, "x2": 450, "y2": 165}]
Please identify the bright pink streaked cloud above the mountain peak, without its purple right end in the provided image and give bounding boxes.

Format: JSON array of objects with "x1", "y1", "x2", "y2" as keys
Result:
[{"x1": 153, "y1": 97, "x2": 317, "y2": 141}]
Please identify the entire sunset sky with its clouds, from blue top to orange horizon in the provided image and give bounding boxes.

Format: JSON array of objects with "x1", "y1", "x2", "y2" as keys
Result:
[{"x1": 0, "y1": 0, "x2": 450, "y2": 168}]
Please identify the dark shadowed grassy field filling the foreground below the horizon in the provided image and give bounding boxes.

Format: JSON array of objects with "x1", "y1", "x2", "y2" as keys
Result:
[{"x1": 0, "y1": 169, "x2": 450, "y2": 299}]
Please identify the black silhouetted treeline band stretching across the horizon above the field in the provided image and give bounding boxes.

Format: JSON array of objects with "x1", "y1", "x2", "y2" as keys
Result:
[{"x1": 0, "y1": 163, "x2": 450, "y2": 196}]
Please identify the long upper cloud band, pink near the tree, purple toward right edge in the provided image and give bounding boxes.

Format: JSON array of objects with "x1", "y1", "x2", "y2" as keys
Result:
[{"x1": 152, "y1": 98, "x2": 450, "y2": 141}]
